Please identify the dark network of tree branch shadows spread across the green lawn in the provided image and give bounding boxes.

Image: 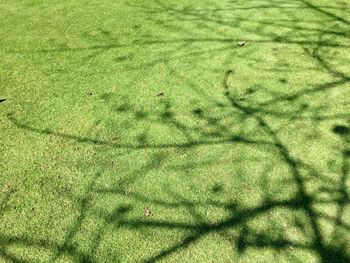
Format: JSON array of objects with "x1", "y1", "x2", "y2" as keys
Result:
[{"x1": 0, "y1": 0, "x2": 350, "y2": 263}]
